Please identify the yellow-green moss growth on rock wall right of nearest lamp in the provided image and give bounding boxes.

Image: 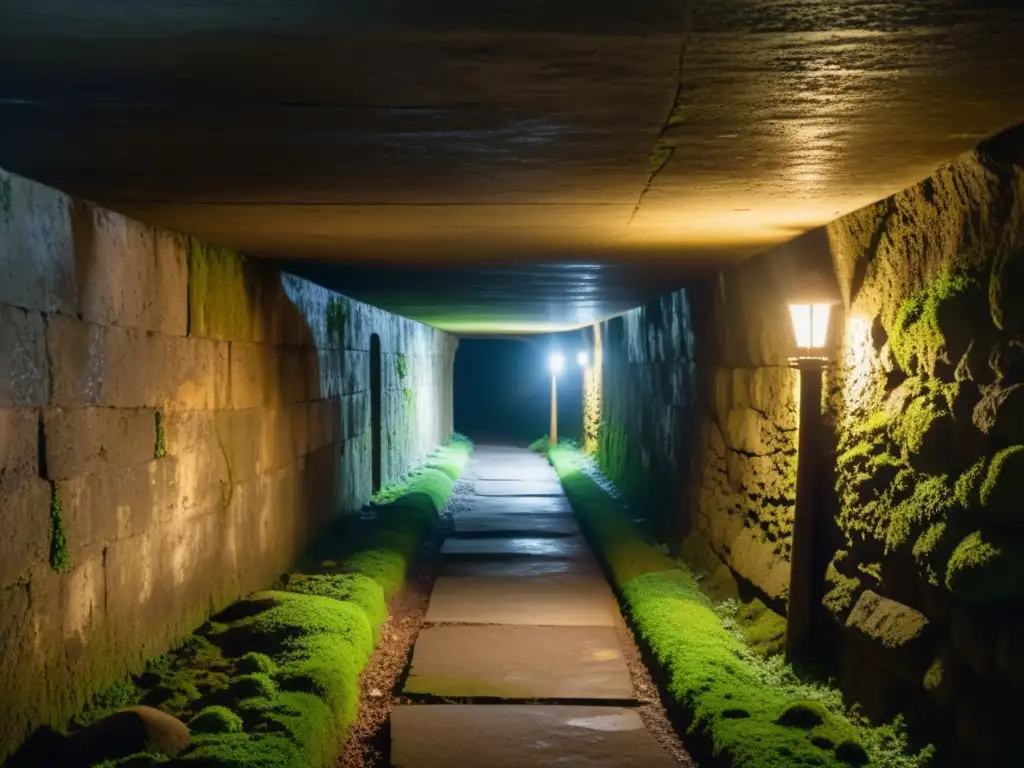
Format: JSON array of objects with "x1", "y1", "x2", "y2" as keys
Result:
[{"x1": 829, "y1": 262, "x2": 1024, "y2": 608}]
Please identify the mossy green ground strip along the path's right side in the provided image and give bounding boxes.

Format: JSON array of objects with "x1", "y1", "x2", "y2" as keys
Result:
[{"x1": 548, "y1": 445, "x2": 928, "y2": 768}]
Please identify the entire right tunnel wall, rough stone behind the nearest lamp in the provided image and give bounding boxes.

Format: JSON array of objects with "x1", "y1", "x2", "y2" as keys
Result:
[{"x1": 598, "y1": 130, "x2": 1024, "y2": 765}]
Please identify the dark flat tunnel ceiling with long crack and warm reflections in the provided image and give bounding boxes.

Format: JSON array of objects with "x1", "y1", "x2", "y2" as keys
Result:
[{"x1": 0, "y1": 0, "x2": 1024, "y2": 332}]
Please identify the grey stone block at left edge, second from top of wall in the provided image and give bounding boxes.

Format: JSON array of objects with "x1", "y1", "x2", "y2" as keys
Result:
[{"x1": 0, "y1": 304, "x2": 50, "y2": 408}]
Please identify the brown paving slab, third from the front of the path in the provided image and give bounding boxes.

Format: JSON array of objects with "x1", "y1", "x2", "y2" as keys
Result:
[{"x1": 426, "y1": 575, "x2": 620, "y2": 627}]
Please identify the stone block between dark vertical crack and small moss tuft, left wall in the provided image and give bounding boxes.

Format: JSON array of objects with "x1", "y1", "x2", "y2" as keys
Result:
[{"x1": 44, "y1": 408, "x2": 157, "y2": 480}]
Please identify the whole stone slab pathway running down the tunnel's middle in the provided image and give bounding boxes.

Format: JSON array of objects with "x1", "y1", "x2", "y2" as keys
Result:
[{"x1": 390, "y1": 446, "x2": 677, "y2": 768}]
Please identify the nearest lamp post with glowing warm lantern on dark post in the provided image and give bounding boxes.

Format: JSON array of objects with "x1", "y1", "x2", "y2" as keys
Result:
[{"x1": 785, "y1": 301, "x2": 831, "y2": 663}]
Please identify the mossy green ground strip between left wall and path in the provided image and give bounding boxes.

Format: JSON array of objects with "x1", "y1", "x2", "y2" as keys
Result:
[{"x1": 78, "y1": 436, "x2": 472, "y2": 768}]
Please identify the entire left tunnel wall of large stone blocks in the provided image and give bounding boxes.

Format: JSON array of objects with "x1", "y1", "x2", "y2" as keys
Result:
[{"x1": 0, "y1": 165, "x2": 456, "y2": 760}]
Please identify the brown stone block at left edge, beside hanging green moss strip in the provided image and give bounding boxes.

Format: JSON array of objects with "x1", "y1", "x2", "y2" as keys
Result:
[{"x1": 0, "y1": 477, "x2": 51, "y2": 585}]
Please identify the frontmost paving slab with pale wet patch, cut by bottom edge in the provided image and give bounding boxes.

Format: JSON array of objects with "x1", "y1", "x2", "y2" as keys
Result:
[{"x1": 391, "y1": 705, "x2": 676, "y2": 768}]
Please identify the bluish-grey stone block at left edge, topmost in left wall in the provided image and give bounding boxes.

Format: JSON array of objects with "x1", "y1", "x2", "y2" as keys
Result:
[{"x1": 0, "y1": 170, "x2": 77, "y2": 314}]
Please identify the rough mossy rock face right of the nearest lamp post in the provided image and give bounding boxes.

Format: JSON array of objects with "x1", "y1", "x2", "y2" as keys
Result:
[{"x1": 825, "y1": 130, "x2": 1024, "y2": 764}]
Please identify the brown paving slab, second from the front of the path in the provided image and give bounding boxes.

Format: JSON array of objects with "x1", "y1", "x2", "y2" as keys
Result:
[{"x1": 403, "y1": 626, "x2": 636, "y2": 702}]
